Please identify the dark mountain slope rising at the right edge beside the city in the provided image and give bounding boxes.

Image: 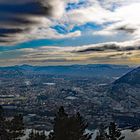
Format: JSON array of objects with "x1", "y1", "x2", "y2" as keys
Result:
[{"x1": 108, "y1": 67, "x2": 140, "y2": 111}]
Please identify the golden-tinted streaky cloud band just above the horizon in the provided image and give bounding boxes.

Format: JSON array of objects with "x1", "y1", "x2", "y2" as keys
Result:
[{"x1": 0, "y1": 40, "x2": 140, "y2": 65}]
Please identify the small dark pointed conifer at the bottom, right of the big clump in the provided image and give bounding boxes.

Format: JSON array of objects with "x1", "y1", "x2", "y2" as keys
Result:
[{"x1": 106, "y1": 122, "x2": 125, "y2": 140}]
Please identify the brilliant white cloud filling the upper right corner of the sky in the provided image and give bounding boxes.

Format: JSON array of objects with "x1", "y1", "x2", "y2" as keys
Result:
[{"x1": 60, "y1": 0, "x2": 140, "y2": 37}]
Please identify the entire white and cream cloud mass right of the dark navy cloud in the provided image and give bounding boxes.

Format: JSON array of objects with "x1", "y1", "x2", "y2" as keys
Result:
[{"x1": 1, "y1": 0, "x2": 140, "y2": 44}]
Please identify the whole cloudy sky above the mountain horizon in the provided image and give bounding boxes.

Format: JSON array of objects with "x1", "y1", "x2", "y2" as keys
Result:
[{"x1": 0, "y1": 0, "x2": 140, "y2": 66}]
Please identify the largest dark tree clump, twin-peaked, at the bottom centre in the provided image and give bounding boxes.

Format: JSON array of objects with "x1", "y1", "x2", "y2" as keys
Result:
[{"x1": 49, "y1": 107, "x2": 91, "y2": 140}]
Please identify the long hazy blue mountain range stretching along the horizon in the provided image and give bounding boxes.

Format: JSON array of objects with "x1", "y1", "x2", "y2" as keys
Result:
[{"x1": 0, "y1": 64, "x2": 133, "y2": 79}]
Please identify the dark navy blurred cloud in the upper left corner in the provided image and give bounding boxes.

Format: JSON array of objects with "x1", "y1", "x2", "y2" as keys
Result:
[{"x1": 0, "y1": 0, "x2": 61, "y2": 42}]
